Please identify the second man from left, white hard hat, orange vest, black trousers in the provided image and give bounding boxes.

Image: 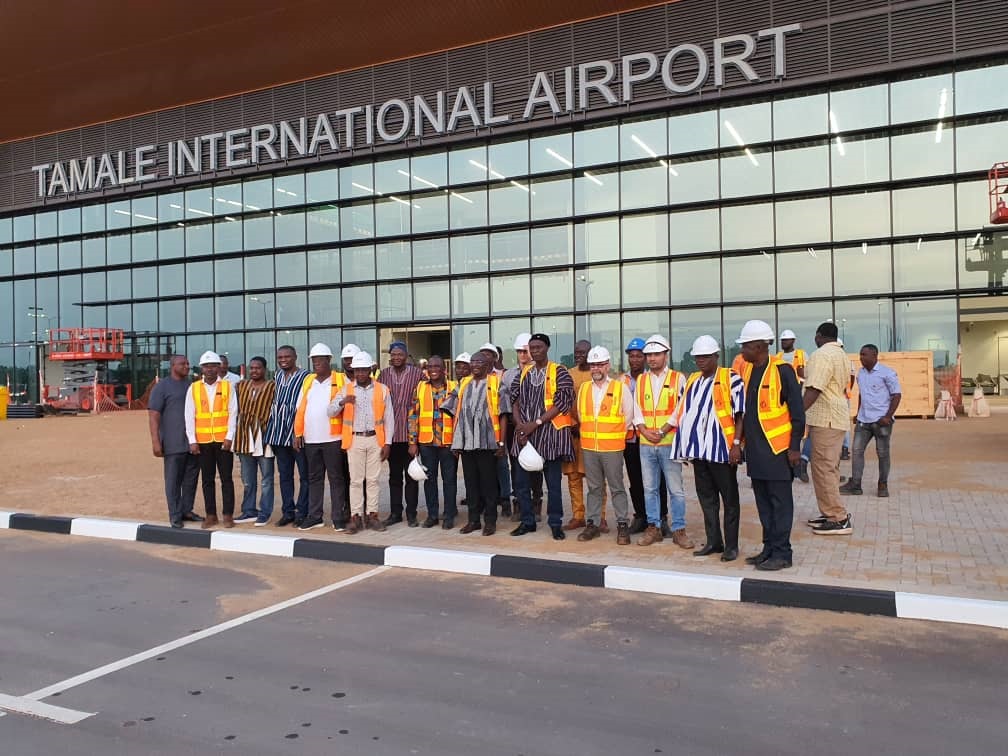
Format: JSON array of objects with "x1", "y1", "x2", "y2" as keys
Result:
[{"x1": 185, "y1": 352, "x2": 238, "y2": 529}]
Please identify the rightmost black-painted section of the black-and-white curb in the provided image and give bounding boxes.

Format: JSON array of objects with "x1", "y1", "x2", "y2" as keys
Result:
[{"x1": 742, "y1": 578, "x2": 896, "y2": 617}]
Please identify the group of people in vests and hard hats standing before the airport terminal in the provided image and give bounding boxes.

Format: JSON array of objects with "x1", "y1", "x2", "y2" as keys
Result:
[{"x1": 149, "y1": 321, "x2": 899, "y2": 571}]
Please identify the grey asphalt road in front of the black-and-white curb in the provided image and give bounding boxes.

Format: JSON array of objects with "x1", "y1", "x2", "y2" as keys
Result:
[{"x1": 0, "y1": 531, "x2": 1008, "y2": 756}]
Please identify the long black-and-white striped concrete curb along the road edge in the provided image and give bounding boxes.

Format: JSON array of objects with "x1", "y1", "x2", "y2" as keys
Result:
[{"x1": 0, "y1": 512, "x2": 1008, "y2": 629}]
